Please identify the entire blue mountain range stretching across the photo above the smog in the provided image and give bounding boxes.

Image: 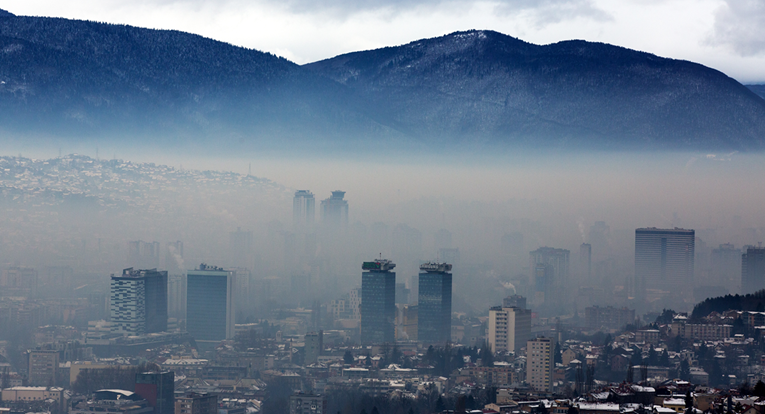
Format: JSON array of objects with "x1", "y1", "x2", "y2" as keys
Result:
[{"x1": 0, "y1": 12, "x2": 765, "y2": 153}]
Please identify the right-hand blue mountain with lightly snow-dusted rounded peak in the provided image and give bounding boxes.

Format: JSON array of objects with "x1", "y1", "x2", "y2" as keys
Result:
[{"x1": 306, "y1": 31, "x2": 765, "y2": 150}]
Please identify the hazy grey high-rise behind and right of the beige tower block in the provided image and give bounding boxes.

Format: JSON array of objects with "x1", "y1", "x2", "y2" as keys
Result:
[{"x1": 530, "y1": 247, "x2": 569, "y2": 304}]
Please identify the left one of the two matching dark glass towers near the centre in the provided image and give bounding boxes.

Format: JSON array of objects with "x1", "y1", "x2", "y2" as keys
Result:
[{"x1": 360, "y1": 259, "x2": 396, "y2": 344}]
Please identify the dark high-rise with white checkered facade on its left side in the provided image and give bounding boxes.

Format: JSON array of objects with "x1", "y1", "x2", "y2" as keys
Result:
[{"x1": 110, "y1": 267, "x2": 167, "y2": 335}]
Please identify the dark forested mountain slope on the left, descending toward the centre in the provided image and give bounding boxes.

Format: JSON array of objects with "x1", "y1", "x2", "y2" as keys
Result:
[{"x1": 0, "y1": 15, "x2": 394, "y2": 148}]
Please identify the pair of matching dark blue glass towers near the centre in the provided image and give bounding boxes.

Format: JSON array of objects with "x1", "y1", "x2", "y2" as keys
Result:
[{"x1": 360, "y1": 259, "x2": 452, "y2": 344}]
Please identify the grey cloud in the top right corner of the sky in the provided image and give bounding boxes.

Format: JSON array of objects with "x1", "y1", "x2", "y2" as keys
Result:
[{"x1": 708, "y1": 0, "x2": 765, "y2": 56}]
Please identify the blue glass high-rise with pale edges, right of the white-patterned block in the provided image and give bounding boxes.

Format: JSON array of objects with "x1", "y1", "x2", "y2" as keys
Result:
[{"x1": 186, "y1": 263, "x2": 235, "y2": 345}]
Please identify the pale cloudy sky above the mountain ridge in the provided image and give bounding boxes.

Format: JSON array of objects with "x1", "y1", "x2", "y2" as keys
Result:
[{"x1": 0, "y1": 0, "x2": 765, "y2": 83}]
